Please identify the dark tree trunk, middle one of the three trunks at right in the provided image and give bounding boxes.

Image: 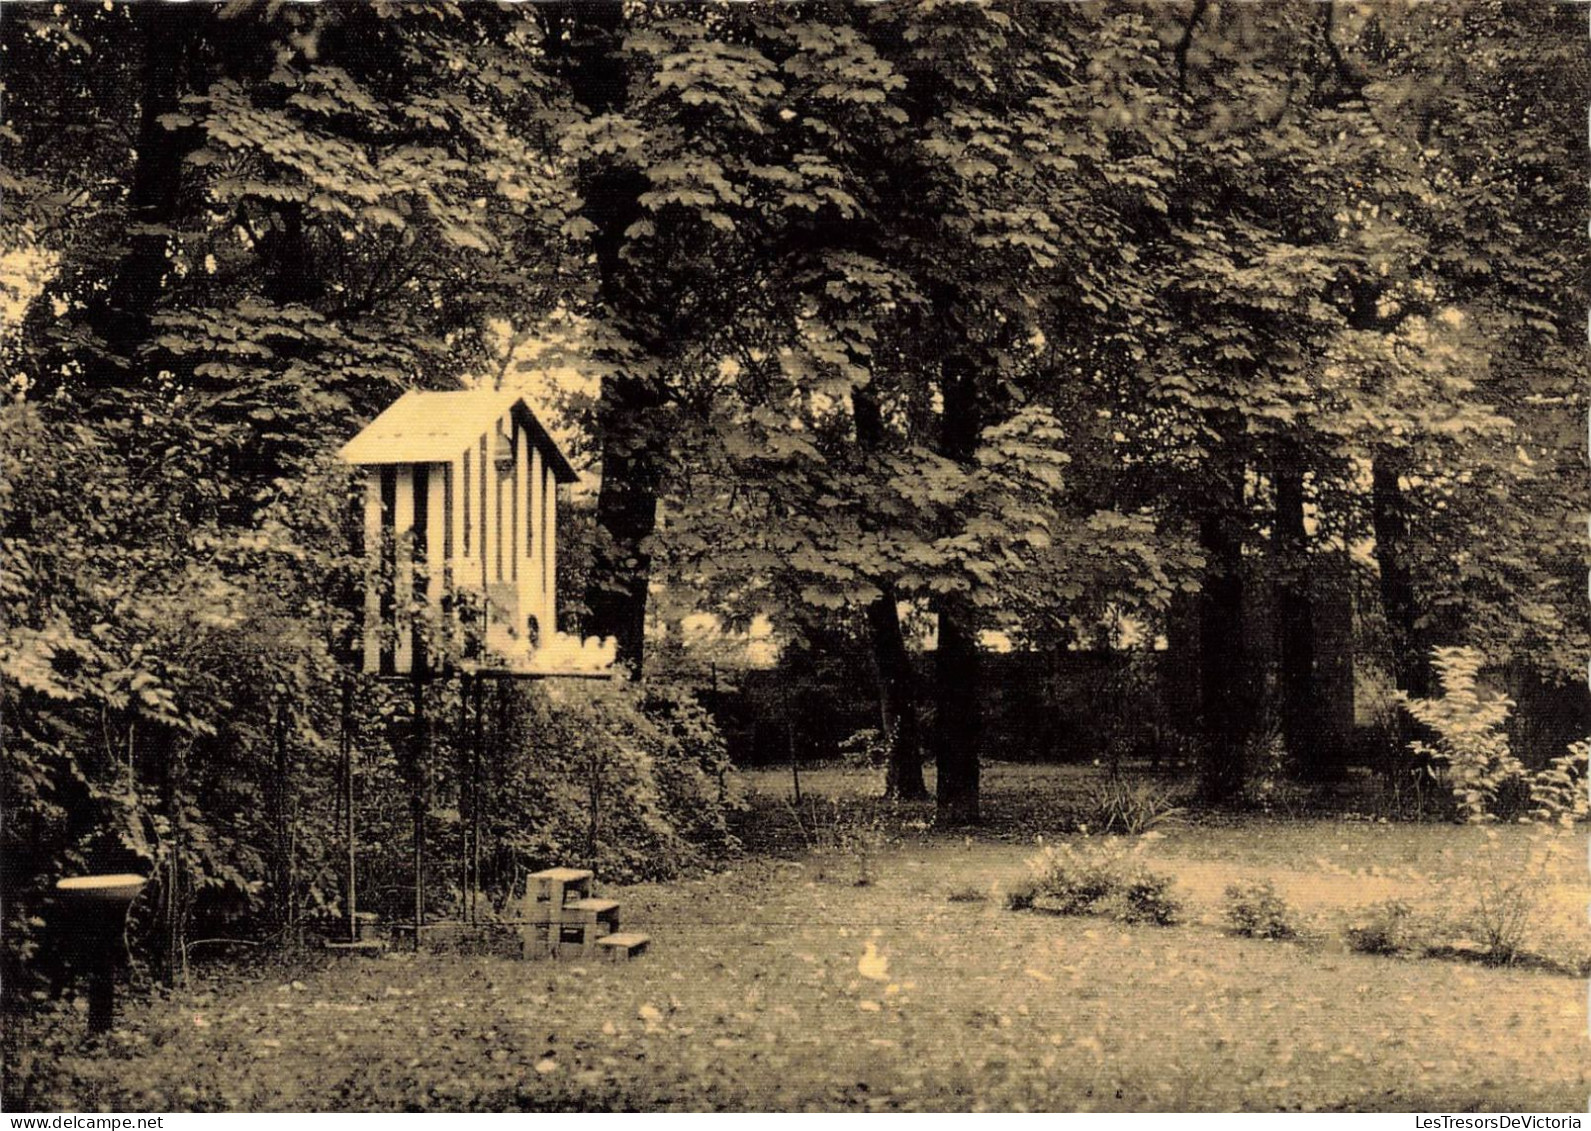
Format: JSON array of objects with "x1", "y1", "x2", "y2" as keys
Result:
[{"x1": 1271, "y1": 445, "x2": 1341, "y2": 781}]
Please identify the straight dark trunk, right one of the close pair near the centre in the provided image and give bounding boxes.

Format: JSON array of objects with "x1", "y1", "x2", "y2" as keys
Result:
[{"x1": 934, "y1": 350, "x2": 983, "y2": 824}]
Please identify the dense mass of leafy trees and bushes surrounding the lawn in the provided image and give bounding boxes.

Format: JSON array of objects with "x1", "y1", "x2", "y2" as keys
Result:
[{"x1": 0, "y1": 0, "x2": 1588, "y2": 1011}]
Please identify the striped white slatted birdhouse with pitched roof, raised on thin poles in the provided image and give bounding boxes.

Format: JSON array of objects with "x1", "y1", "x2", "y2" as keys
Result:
[{"x1": 342, "y1": 390, "x2": 578, "y2": 674}]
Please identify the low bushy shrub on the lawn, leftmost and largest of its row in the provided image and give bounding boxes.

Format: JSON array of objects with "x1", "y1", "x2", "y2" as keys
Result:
[{"x1": 1006, "y1": 838, "x2": 1181, "y2": 926}]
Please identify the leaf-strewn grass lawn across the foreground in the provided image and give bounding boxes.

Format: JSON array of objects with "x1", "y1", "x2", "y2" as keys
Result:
[{"x1": 6, "y1": 767, "x2": 1591, "y2": 1110}]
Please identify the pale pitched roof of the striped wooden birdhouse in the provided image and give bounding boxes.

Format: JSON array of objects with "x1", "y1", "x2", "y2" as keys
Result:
[{"x1": 339, "y1": 388, "x2": 579, "y2": 484}]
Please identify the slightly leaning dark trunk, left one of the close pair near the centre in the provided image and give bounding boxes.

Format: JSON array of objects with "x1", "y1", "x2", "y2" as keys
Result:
[{"x1": 851, "y1": 388, "x2": 928, "y2": 800}]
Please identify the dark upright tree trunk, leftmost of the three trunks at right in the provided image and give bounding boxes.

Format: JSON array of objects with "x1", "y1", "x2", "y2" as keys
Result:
[{"x1": 1200, "y1": 463, "x2": 1254, "y2": 802}]
